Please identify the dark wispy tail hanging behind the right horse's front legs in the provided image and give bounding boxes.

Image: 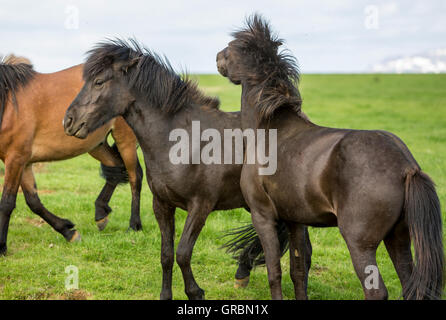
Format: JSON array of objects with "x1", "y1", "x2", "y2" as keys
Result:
[{"x1": 221, "y1": 221, "x2": 289, "y2": 269}]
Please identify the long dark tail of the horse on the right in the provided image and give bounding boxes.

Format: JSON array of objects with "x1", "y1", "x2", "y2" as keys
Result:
[{"x1": 404, "y1": 170, "x2": 444, "y2": 299}]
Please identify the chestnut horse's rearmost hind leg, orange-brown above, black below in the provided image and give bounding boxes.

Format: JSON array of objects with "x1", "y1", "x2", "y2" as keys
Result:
[{"x1": 112, "y1": 122, "x2": 143, "y2": 231}]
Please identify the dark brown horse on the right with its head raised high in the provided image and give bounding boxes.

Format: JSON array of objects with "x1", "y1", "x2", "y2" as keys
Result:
[{"x1": 217, "y1": 15, "x2": 444, "y2": 299}]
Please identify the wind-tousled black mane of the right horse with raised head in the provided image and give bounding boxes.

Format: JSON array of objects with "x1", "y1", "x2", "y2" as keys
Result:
[{"x1": 230, "y1": 14, "x2": 302, "y2": 120}]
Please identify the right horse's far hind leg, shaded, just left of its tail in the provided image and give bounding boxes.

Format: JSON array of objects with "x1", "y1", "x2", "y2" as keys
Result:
[{"x1": 384, "y1": 219, "x2": 413, "y2": 299}]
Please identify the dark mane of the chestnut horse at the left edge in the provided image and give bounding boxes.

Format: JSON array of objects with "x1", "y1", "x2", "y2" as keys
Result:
[{"x1": 0, "y1": 54, "x2": 36, "y2": 128}]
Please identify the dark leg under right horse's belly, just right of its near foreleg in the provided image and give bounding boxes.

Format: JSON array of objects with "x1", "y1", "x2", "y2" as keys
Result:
[{"x1": 287, "y1": 222, "x2": 311, "y2": 300}]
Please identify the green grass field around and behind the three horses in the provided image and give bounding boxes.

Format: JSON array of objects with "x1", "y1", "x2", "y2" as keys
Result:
[{"x1": 0, "y1": 75, "x2": 446, "y2": 299}]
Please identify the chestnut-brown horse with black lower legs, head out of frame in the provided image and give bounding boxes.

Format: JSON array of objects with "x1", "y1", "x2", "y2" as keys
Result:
[{"x1": 0, "y1": 55, "x2": 142, "y2": 254}]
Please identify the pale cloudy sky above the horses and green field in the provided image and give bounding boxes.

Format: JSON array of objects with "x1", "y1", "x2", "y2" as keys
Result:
[{"x1": 0, "y1": 0, "x2": 446, "y2": 73}]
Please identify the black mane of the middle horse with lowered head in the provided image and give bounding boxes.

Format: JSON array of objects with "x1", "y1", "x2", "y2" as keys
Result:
[{"x1": 84, "y1": 39, "x2": 220, "y2": 113}]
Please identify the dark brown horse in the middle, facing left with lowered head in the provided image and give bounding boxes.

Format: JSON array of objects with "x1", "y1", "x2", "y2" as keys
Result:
[{"x1": 65, "y1": 40, "x2": 307, "y2": 299}]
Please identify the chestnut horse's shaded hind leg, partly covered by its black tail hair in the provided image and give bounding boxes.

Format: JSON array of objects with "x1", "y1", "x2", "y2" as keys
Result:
[{"x1": 89, "y1": 142, "x2": 122, "y2": 231}]
